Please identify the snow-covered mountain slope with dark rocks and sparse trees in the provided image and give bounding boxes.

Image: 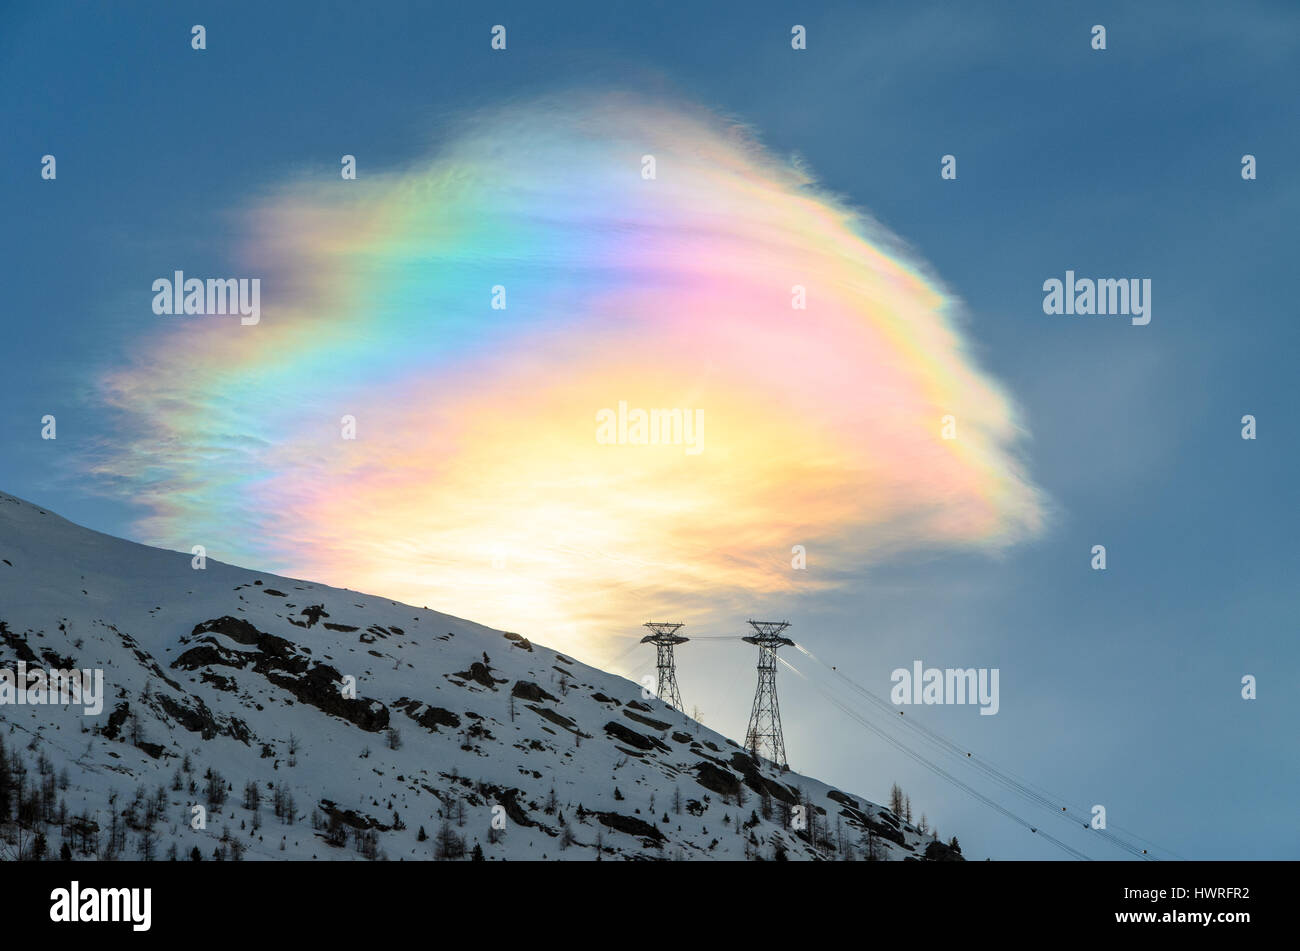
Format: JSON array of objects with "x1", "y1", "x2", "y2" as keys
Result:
[{"x1": 0, "y1": 494, "x2": 959, "y2": 860}]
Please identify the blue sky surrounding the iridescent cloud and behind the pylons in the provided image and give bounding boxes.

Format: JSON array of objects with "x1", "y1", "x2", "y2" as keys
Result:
[{"x1": 0, "y1": 3, "x2": 1300, "y2": 859}]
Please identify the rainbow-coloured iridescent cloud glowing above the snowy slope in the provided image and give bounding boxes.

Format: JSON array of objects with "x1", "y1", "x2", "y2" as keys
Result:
[{"x1": 91, "y1": 95, "x2": 1044, "y2": 657}]
